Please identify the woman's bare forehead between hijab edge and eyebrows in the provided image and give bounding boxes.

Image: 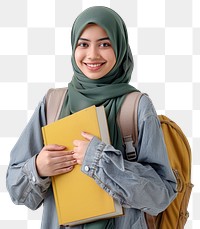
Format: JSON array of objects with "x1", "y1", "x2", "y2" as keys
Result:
[{"x1": 80, "y1": 24, "x2": 108, "y2": 39}]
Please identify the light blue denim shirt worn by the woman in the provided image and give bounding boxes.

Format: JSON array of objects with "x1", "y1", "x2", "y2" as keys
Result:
[{"x1": 7, "y1": 96, "x2": 176, "y2": 229}]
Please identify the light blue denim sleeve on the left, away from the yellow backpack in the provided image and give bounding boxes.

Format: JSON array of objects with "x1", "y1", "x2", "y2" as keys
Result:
[{"x1": 6, "y1": 97, "x2": 51, "y2": 209}]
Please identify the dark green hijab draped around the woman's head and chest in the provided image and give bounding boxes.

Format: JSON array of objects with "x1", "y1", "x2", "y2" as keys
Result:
[{"x1": 60, "y1": 6, "x2": 136, "y2": 150}]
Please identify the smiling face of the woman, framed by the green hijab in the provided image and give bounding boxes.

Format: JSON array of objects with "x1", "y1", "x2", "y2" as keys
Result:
[{"x1": 75, "y1": 24, "x2": 116, "y2": 79}]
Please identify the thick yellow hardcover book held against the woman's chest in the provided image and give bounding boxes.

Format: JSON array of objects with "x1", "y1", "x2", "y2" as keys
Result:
[{"x1": 42, "y1": 106, "x2": 123, "y2": 226}]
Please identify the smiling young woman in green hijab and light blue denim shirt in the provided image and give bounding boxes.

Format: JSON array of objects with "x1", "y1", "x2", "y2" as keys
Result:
[{"x1": 7, "y1": 6, "x2": 176, "y2": 229}]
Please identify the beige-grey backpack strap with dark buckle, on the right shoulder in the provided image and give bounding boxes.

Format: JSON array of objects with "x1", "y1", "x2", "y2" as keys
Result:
[{"x1": 117, "y1": 92, "x2": 143, "y2": 161}]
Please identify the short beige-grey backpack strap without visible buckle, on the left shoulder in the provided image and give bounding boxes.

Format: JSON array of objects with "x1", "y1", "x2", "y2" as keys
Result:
[{"x1": 45, "y1": 87, "x2": 67, "y2": 124}]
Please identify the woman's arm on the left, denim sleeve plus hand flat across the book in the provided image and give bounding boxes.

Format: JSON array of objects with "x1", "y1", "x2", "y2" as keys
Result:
[{"x1": 7, "y1": 99, "x2": 76, "y2": 209}]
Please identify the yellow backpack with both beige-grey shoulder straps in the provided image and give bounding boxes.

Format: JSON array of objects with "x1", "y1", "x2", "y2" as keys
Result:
[{"x1": 46, "y1": 88, "x2": 193, "y2": 229}]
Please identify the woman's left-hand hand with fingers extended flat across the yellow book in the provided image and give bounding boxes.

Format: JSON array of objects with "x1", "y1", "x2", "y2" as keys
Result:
[{"x1": 36, "y1": 145, "x2": 77, "y2": 177}]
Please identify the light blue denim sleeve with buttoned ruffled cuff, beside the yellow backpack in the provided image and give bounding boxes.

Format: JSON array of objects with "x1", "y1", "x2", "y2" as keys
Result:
[{"x1": 82, "y1": 96, "x2": 176, "y2": 215}]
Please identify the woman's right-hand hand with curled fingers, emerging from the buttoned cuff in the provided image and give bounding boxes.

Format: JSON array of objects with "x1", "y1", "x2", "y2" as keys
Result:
[{"x1": 73, "y1": 132, "x2": 94, "y2": 165}]
